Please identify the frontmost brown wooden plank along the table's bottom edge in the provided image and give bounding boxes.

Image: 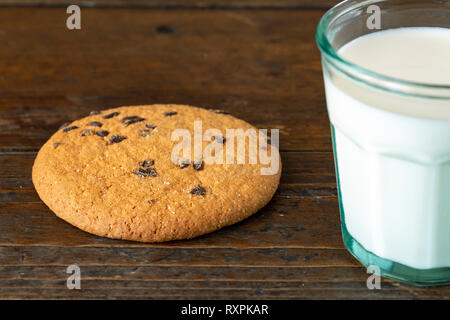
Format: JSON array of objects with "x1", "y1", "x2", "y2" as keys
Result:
[{"x1": 0, "y1": 266, "x2": 450, "y2": 299}]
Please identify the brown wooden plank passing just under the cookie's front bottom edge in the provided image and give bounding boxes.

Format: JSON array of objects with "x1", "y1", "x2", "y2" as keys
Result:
[{"x1": 0, "y1": 198, "x2": 342, "y2": 248}]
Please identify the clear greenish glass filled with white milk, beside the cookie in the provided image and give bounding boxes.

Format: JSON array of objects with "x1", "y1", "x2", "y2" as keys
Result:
[{"x1": 317, "y1": 0, "x2": 450, "y2": 286}]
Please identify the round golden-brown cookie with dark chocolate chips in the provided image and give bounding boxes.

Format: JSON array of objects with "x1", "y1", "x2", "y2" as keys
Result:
[{"x1": 32, "y1": 105, "x2": 281, "y2": 242}]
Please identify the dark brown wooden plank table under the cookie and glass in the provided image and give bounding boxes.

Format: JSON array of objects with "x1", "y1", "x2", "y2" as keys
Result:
[{"x1": 0, "y1": 0, "x2": 450, "y2": 299}]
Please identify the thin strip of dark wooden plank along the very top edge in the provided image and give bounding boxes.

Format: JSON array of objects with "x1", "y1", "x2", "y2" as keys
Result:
[{"x1": 0, "y1": 0, "x2": 339, "y2": 9}]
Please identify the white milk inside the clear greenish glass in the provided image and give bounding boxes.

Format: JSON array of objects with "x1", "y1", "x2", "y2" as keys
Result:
[{"x1": 325, "y1": 27, "x2": 450, "y2": 269}]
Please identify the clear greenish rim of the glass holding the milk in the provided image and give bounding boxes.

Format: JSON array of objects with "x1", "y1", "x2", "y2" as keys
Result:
[{"x1": 316, "y1": 0, "x2": 450, "y2": 99}]
